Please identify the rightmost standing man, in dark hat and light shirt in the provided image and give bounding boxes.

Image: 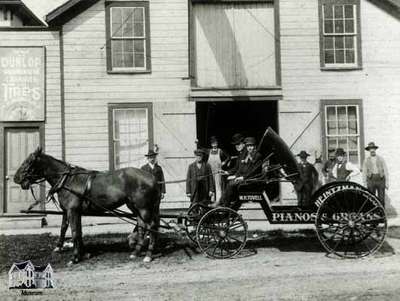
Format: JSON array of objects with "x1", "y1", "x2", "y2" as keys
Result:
[{"x1": 363, "y1": 142, "x2": 388, "y2": 206}]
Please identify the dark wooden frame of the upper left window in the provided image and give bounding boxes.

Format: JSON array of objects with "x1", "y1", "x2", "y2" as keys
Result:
[{"x1": 105, "y1": 1, "x2": 151, "y2": 74}]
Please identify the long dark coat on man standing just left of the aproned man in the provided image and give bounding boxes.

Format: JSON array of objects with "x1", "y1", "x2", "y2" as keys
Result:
[{"x1": 186, "y1": 162, "x2": 215, "y2": 202}]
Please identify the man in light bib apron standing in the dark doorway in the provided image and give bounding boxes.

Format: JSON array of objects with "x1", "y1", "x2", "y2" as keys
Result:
[{"x1": 207, "y1": 136, "x2": 229, "y2": 201}]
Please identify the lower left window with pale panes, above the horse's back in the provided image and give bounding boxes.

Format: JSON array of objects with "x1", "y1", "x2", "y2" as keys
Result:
[{"x1": 110, "y1": 104, "x2": 152, "y2": 169}]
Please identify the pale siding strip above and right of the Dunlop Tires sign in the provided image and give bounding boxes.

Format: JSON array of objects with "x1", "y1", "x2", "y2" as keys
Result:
[{"x1": 0, "y1": 31, "x2": 61, "y2": 158}]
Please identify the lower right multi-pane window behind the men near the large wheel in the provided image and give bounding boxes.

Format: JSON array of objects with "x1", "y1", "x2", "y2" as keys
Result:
[{"x1": 322, "y1": 100, "x2": 363, "y2": 166}]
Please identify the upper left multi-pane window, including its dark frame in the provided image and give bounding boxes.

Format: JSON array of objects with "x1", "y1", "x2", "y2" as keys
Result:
[{"x1": 106, "y1": 1, "x2": 151, "y2": 73}]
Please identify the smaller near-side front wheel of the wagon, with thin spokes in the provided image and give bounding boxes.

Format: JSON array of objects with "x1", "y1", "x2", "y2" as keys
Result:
[{"x1": 196, "y1": 207, "x2": 247, "y2": 259}]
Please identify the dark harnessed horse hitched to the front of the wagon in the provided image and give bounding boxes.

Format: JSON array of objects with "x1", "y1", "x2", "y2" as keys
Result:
[{"x1": 14, "y1": 147, "x2": 161, "y2": 263}]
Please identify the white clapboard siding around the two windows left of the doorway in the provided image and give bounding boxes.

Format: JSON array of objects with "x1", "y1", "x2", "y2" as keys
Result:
[{"x1": 63, "y1": 0, "x2": 196, "y2": 207}]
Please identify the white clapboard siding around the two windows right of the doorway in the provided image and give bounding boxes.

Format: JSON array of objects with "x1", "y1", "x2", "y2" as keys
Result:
[{"x1": 279, "y1": 0, "x2": 400, "y2": 210}]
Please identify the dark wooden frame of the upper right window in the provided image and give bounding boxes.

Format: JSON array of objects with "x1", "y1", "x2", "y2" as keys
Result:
[{"x1": 318, "y1": 0, "x2": 362, "y2": 71}]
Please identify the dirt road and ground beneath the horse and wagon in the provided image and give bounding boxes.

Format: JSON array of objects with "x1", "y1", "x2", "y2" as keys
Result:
[{"x1": 0, "y1": 228, "x2": 400, "y2": 300}]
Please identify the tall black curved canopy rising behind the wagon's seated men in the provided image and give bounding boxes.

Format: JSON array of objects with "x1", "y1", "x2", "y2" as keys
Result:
[{"x1": 258, "y1": 127, "x2": 299, "y2": 182}]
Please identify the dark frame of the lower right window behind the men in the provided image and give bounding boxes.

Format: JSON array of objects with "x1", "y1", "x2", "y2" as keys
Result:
[{"x1": 320, "y1": 99, "x2": 365, "y2": 168}]
